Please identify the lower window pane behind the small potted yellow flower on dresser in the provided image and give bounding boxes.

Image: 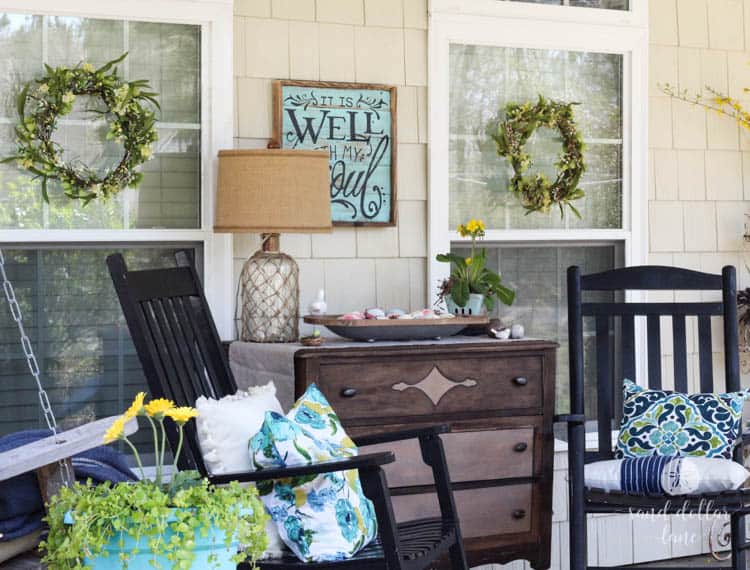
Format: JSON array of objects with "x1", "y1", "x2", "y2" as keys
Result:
[{"x1": 453, "y1": 241, "x2": 622, "y2": 416}]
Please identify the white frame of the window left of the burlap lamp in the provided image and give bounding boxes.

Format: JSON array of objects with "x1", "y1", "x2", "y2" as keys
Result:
[{"x1": 0, "y1": 0, "x2": 234, "y2": 339}]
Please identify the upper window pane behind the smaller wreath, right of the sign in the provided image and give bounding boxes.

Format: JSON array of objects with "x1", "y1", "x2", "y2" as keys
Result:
[{"x1": 449, "y1": 44, "x2": 623, "y2": 229}]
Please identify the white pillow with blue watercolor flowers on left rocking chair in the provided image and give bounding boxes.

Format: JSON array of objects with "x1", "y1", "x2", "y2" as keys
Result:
[{"x1": 250, "y1": 385, "x2": 377, "y2": 562}]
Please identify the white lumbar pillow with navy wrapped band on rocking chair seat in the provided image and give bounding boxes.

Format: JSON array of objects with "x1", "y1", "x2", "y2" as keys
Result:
[{"x1": 585, "y1": 457, "x2": 750, "y2": 496}]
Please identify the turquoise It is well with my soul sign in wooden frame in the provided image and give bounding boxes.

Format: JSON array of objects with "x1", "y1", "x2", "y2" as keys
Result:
[{"x1": 273, "y1": 80, "x2": 397, "y2": 226}]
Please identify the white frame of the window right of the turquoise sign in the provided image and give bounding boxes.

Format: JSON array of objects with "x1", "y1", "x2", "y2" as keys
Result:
[{"x1": 428, "y1": 0, "x2": 648, "y2": 299}]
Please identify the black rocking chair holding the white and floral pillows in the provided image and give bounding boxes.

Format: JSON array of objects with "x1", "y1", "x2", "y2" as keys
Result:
[{"x1": 107, "y1": 252, "x2": 468, "y2": 570}]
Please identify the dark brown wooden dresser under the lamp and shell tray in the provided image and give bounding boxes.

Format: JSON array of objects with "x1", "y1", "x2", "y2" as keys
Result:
[{"x1": 294, "y1": 338, "x2": 557, "y2": 569}]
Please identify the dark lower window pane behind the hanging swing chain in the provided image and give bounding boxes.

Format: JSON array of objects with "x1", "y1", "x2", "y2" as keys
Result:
[{"x1": 0, "y1": 245, "x2": 202, "y2": 460}]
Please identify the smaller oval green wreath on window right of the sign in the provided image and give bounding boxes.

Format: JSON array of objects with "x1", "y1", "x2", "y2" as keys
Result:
[{"x1": 491, "y1": 95, "x2": 586, "y2": 218}]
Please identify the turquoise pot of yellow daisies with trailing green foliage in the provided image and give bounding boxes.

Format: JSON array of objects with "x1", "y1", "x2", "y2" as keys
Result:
[{"x1": 42, "y1": 393, "x2": 268, "y2": 570}]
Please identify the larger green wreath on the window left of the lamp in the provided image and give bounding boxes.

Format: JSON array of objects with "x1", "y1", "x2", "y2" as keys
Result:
[{"x1": 2, "y1": 53, "x2": 159, "y2": 205}]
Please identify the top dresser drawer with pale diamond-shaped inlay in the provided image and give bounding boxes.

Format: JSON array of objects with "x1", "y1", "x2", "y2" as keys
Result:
[{"x1": 318, "y1": 356, "x2": 543, "y2": 420}]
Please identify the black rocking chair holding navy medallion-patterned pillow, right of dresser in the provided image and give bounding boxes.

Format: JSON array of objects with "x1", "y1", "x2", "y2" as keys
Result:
[{"x1": 558, "y1": 266, "x2": 750, "y2": 570}]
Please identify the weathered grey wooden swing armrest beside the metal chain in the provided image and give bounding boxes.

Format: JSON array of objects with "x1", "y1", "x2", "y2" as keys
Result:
[{"x1": 0, "y1": 416, "x2": 138, "y2": 481}]
